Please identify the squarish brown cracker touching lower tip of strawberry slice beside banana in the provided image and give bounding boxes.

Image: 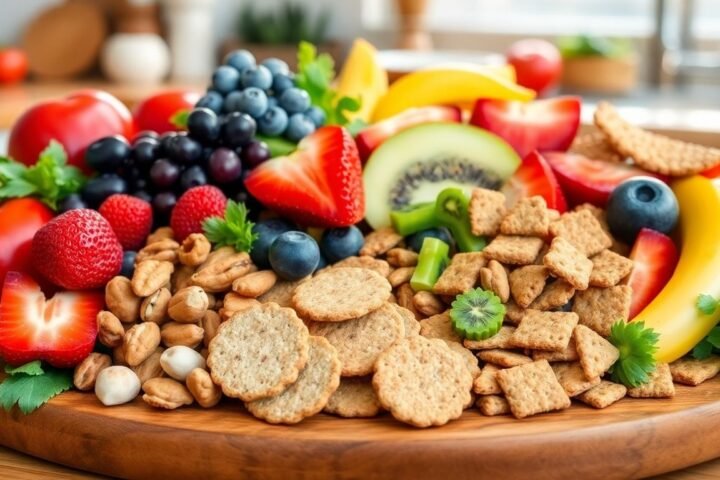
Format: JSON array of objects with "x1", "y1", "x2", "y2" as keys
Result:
[{"x1": 572, "y1": 285, "x2": 632, "y2": 337}]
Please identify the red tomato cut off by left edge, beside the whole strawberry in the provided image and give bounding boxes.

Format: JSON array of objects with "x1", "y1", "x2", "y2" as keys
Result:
[{"x1": 0, "y1": 198, "x2": 53, "y2": 288}]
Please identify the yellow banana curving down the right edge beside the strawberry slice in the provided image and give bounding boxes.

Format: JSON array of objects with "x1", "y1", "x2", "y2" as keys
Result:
[{"x1": 633, "y1": 175, "x2": 720, "y2": 362}]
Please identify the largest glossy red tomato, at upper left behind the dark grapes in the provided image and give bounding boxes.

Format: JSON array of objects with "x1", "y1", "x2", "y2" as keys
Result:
[{"x1": 8, "y1": 90, "x2": 133, "y2": 173}]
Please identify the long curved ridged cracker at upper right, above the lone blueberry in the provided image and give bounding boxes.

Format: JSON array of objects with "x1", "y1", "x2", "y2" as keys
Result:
[{"x1": 595, "y1": 102, "x2": 720, "y2": 177}]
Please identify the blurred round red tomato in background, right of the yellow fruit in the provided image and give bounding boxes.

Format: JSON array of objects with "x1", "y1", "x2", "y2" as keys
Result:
[{"x1": 506, "y1": 38, "x2": 562, "y2": 95}]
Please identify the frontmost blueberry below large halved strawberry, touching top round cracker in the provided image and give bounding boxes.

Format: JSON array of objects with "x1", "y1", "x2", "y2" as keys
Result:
[{"x1": 268, "y1": 231, "x2": 320, "y2": 280}]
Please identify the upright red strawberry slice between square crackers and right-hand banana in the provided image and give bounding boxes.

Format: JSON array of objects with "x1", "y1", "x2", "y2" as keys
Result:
[{"x1": 628, "y1": 228, "x2": 678, "y2": 320}]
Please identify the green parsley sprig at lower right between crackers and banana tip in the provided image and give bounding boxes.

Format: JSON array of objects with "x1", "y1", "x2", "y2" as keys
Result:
[{"x1": 609, "y1": 320, "x2": 660, "y2": 388}]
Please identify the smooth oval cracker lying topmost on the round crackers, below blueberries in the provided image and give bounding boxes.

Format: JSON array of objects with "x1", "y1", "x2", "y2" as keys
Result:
[{"x1": 293, "y1": 268, "x2": 392, "y2": 322}]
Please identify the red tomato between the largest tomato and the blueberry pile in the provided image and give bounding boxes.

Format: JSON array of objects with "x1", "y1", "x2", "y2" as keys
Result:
[{"x1": 133, "y1": 90, "x2": 200, "y2": 133}]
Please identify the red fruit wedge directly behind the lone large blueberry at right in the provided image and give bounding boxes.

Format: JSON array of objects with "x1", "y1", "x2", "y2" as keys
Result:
[{"x1": 544, "y1": 152, "x2": 668, "y2": 207}]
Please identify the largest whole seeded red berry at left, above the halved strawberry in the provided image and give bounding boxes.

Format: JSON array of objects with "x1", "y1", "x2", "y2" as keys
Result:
[{"x1": 31, "y1": 208, "x2": 123, "y2": 290}]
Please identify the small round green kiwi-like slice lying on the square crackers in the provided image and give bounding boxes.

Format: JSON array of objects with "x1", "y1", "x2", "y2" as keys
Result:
[{"x1": 450, "y1": 288, "x2": 505, "y2": 340}]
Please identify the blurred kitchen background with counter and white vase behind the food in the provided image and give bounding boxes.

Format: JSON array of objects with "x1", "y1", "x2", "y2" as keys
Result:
[{"x1": 0, "y1": 0, "x2": 720, "y2": 151}]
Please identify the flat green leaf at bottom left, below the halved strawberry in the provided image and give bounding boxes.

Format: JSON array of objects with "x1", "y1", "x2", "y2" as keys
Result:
[{"x1": 0, "y1": 368, "x2": 73, "y2": 415}]
